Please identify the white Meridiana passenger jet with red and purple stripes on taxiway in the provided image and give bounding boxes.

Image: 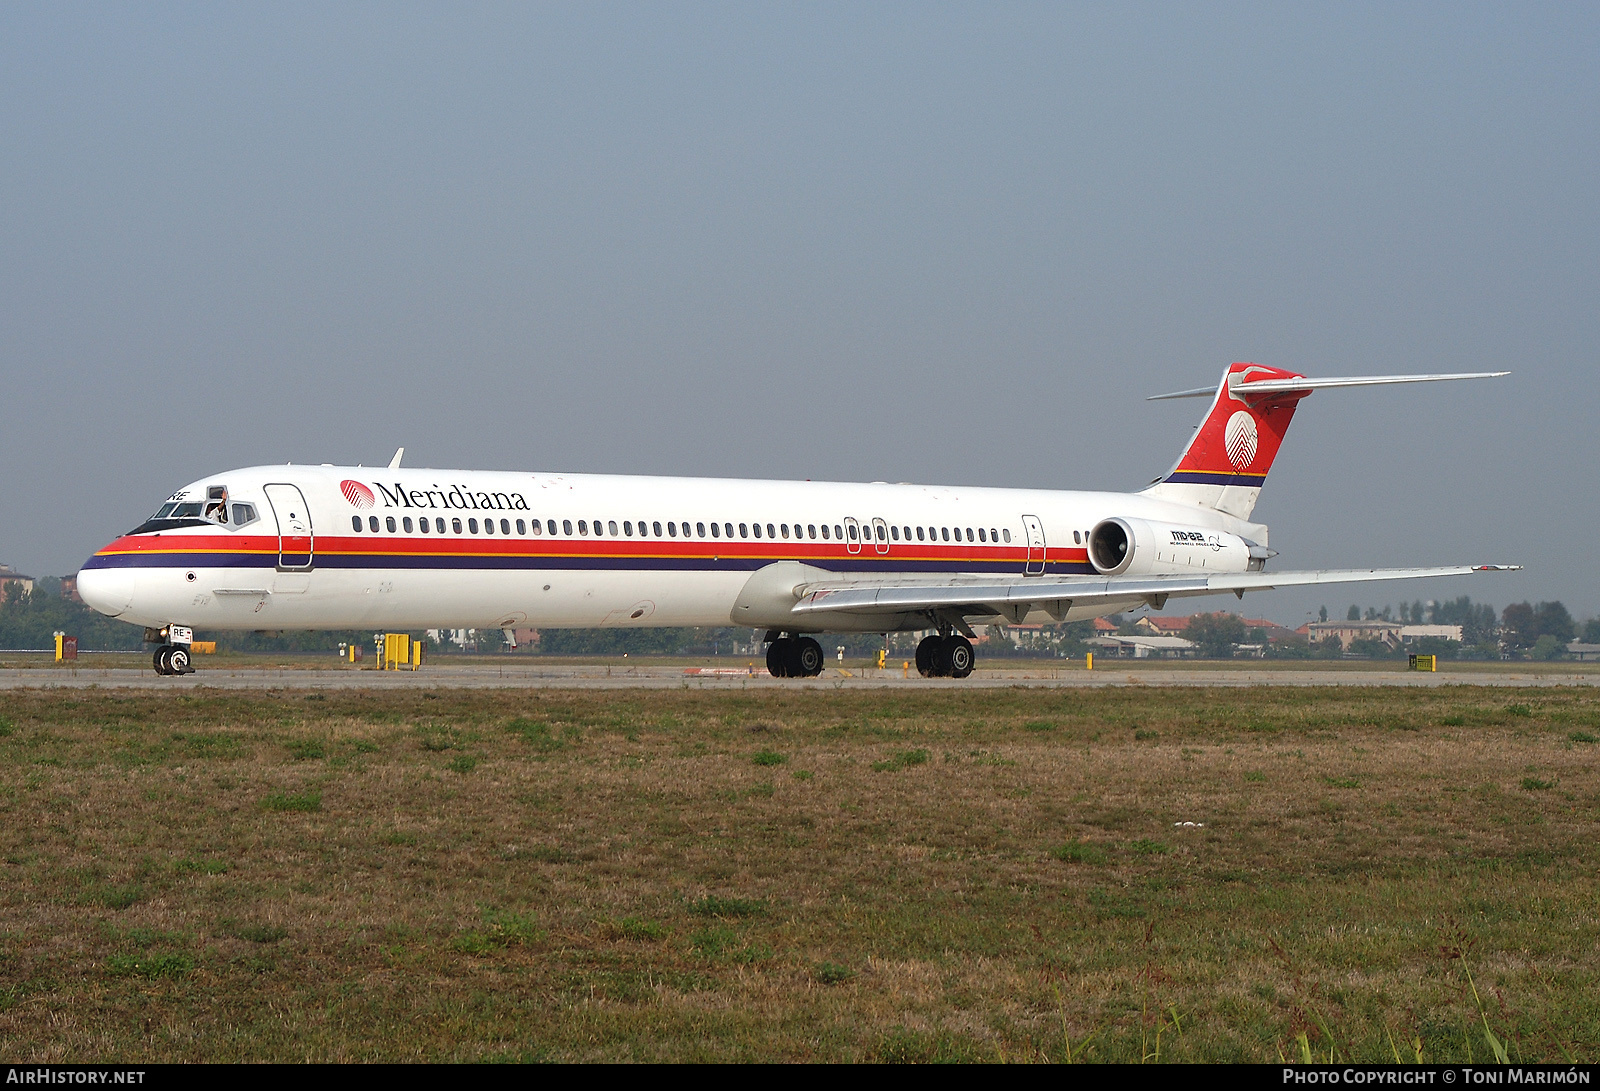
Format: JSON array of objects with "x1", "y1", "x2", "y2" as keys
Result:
[{"x1": 78, "y1": 363, "x2": 1518, "y2": 678}]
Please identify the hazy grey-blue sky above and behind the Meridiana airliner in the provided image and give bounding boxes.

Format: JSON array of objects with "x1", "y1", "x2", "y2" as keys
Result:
[{"x1": 0, "y1": 3, "x2": 1600, "y2": 624}]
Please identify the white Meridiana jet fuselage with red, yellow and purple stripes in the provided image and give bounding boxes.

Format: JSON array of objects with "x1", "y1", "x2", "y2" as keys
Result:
[{"x1": 78, "y1": 466, "x2": 1266, "y2": 632}]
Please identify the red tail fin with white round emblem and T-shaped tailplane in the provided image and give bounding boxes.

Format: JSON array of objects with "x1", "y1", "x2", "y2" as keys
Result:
[{"x1": 1146, "y1": 363, "x2": 1510, "y2": 520}]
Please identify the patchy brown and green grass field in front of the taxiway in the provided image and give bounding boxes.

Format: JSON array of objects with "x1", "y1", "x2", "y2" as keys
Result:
[{"x1": 0, "y1": 686, "x2": 1600, "y2": 1062}]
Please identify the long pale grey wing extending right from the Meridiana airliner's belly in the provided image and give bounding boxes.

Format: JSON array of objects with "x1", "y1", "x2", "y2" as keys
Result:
[{"x1": 794, "y1": 565, "x2": 1522, "y2": 622}]
